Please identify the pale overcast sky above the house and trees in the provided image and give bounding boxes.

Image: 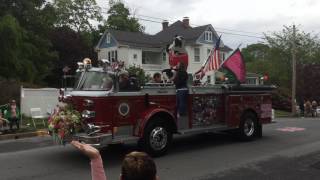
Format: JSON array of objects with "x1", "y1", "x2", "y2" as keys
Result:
[{"x1": 97, "y1": 0, "x2": 320, "y2": 48}]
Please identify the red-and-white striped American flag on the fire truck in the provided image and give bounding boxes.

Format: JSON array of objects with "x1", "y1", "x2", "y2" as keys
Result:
[{"x1": 195, "y1": 36, "x2": 221, "y2": 79}]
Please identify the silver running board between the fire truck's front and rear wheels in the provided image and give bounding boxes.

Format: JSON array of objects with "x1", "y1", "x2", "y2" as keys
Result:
[{"x1": 178, "y1": 125, "x2": 232, "y2": 135}]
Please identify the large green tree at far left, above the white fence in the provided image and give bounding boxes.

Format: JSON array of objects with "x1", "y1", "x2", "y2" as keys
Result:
[{"x1": 0, "y1": 0, "x2": 56, "y2": 84}]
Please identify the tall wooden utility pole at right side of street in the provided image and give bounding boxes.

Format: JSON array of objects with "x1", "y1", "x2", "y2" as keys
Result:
[{"x1": 291, "y1": 25, "x2": 296, "y2": 116}]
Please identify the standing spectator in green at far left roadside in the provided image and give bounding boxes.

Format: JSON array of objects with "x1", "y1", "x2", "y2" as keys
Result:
[{"x1": 5, "y1": 100, "x2": 20, "y2": 131}]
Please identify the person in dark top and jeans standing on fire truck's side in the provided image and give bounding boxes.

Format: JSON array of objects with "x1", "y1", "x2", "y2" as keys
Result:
[{"x1": 173, "y1": 62, "x2": 188, "y2": 118}]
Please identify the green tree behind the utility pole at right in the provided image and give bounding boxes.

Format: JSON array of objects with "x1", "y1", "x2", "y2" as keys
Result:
[{"x1": 242, "y1": 26, "x2": 320, "y2": 93}]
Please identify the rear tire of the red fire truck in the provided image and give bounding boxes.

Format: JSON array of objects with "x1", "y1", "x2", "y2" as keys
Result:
[{"x1": 238, "y1": 112, "x2": 259, "y2": 141}]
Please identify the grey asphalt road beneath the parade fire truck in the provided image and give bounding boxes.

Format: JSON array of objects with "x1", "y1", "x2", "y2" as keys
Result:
[{"x1": 0, "y1": 118, "x2": 320, "y2": 180}]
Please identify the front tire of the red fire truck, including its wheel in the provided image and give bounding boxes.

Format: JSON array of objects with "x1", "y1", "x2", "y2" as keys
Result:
[{"x1": 140, "y1": 118, "x2": 172, "y2": 157}]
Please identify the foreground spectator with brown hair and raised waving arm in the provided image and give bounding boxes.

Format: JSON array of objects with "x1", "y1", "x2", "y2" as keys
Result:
[{"x1": 71, "y1": 141, "x2": 158, "y2": 180}]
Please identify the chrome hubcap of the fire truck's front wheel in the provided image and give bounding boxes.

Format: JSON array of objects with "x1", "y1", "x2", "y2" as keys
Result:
[{"x1": 150, "y1": 127, "x2": 168, "y2": 150}]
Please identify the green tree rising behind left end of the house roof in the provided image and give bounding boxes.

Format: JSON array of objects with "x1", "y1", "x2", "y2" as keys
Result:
[{"x1": 104, "y1": 1, "x2": 145, "y2": 32}]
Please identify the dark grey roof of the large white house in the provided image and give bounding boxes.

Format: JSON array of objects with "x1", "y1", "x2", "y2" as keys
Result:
[{"x1": 99, "y1": 21, "x2": 232, "y2": 51}]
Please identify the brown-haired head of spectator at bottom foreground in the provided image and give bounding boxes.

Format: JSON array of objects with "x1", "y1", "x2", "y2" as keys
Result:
[{"x1": 121, "y1": 152, "x2": 157, "y2": 180}]
